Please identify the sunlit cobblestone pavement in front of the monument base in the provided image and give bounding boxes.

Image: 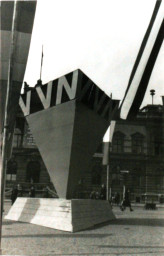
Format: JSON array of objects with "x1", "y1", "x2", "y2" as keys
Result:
[{"x1": 2, "y1": 203, "x2": 164, "y2": 256}]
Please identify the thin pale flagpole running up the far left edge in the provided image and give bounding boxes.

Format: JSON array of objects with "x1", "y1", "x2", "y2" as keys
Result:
[{"x1": 0, "y1": 0, "x2": 18, "y2": 242}]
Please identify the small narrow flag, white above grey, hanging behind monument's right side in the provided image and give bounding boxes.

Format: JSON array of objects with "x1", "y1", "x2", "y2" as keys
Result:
[{"x1": 102, "y1": 121, "x2": 116, "y2": 165}]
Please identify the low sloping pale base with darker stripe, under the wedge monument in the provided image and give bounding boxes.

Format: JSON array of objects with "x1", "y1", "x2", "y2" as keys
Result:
[{"x1": 5, "y1": 197, "x2": 115, "y2": 232}]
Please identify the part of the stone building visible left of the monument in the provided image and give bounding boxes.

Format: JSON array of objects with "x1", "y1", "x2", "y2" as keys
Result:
[{"x1": 6, "y1": 107, "x2": 53, "y2": 195}]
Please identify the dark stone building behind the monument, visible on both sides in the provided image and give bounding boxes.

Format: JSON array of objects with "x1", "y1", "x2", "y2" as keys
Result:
[{"x1": 6, "y1": 102, "x2": 164, "y2": 201}]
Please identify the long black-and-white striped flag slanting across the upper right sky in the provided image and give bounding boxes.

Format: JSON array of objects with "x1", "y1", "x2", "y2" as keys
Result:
[{"x1": 120, "y1": 0, "x2": 164, "y2": 119}]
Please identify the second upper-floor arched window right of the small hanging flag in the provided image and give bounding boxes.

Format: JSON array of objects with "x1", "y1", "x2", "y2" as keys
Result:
[{"x1": 131, "y1": 133, "x2": 144, "y2": 154}]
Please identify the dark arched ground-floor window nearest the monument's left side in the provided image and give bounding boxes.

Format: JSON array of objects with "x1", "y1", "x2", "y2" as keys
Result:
[{"x1": 26, "y1": 161, "x2": 40, "y2": 183}]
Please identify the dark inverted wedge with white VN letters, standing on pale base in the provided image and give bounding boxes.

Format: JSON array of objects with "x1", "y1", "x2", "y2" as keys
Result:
[{"x1": 20, "y1": 70, "x2": 118, "y2": 199}]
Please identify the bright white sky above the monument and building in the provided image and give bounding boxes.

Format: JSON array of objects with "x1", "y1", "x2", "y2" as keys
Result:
[{"x1": 24, "y1": 0, "x2": 164, "y2": 106}]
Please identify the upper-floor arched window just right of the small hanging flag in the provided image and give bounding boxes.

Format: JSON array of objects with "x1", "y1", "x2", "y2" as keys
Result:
[{"x1": 112, "y1": 131, "x2": 125, "y2": 153}]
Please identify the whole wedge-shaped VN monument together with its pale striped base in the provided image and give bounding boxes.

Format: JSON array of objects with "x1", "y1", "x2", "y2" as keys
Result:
[{"x1": 5, "y1": 70, "x2": 118, "y2": 231}]
